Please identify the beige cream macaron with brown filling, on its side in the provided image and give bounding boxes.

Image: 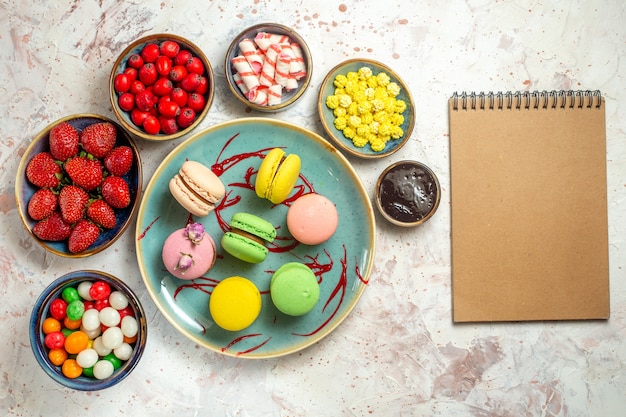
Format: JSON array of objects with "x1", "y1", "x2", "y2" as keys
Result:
[{"x1": 169, "y1": 161, "x2": 226, "y2": 217}]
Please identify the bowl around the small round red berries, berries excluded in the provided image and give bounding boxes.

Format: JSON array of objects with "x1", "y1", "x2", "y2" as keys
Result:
[{"x1": 109, "y1": 34, "x2": 215, "y2": 141}]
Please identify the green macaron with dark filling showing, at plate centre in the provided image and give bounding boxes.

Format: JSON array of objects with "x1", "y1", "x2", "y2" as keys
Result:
[{"x1": 221, "y1": 212, "x2": 276, "y2": 264}]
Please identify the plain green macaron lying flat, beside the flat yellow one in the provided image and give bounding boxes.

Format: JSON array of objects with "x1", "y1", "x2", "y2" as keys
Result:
[{"x1": 270, "y1": 262, "x2": 320, "y2": 316}]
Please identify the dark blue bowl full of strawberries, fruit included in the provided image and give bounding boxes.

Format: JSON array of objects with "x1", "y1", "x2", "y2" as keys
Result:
[{"x1": 15, "y1": 114, "x2": 142, "y2": 258}]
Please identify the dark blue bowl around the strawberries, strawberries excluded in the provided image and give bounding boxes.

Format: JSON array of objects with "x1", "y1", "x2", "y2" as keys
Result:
[{"x1": 15, "y1": 114, "x2": 143, "y2": 258}]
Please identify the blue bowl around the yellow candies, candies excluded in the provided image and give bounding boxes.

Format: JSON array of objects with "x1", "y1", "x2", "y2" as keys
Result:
[{"x1": 317, "y1": 59, "x2": 415, "y2": 159}]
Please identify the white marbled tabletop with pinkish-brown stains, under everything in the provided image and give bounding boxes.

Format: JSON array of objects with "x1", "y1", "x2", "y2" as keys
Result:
[{"x1": 0, "y1": 0, "x2": 626, "y2": 417}]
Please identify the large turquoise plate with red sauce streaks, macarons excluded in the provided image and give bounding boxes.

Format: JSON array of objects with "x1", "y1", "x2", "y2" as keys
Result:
[{"x1": 136, "y1": 118, "x2": 375, "y2": 358}]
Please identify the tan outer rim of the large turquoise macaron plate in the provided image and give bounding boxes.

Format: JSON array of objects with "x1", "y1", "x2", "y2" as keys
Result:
[{"x1": 135, "y1": 116, "x2": 376, "y2": 359}]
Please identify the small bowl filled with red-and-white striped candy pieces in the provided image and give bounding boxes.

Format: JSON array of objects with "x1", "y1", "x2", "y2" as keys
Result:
[{"x1": 224, "y1": 23, "x2": 313, "y2": 112}]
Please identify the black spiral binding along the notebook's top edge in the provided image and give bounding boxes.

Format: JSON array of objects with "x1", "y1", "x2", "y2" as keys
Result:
[{"x1": 451, "y1": 90, "x2": 602, "y2": 111}]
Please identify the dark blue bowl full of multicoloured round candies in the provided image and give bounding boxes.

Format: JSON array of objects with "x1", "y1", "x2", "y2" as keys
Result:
[{"x1": 30, "y1": 270, "x2": 147, "y2": 391}]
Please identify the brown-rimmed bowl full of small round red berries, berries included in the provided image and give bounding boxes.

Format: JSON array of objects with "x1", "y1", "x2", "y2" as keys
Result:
[{"x1": 109, "y1": 34, "x2": 214, "y2": 141}]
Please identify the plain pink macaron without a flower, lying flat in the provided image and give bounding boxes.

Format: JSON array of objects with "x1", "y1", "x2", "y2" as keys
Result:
[{"x1": 287, "y1": 193, "x2": 339, "y2": 245}]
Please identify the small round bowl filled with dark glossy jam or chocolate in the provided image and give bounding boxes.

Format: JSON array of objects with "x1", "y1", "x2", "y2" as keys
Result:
[{"x1": 375, "y1": 161, "x2": 441, "y2": 227}]
